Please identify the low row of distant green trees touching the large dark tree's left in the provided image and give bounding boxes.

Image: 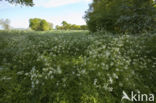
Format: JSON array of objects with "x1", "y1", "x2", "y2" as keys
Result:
[{"x1": 56, "y1": 21, "x2": 88, "y2": 30}]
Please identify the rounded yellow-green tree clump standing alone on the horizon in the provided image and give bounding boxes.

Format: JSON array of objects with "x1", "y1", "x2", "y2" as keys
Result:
[{"x1": 29, "y1": 18, "x2": 52, "y2": 31}]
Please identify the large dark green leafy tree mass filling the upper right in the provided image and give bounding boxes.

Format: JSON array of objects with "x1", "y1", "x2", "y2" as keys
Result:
[{"x1": 85, "y1": 0, "x2": 156, "y2": 33}]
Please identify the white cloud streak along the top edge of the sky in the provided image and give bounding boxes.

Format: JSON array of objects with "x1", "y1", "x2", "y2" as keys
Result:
[{"x1": 34, "y1": 0, "x2": 92, "y2": 8}]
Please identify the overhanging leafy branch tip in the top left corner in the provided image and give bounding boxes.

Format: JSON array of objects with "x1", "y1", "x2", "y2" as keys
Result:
[{"x1": 0, "y1": 0, "x2": 34, "y2": 6}]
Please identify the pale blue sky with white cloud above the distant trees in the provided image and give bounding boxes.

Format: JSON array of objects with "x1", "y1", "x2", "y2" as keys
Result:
[{"x1": 0, "y1": 0, "x2": 92, "y2": 28}]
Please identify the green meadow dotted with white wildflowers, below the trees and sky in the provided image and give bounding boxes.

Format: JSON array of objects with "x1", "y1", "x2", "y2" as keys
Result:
[{"x1": 0, "y1": 31, "x2": 156, "y2": 103}]
